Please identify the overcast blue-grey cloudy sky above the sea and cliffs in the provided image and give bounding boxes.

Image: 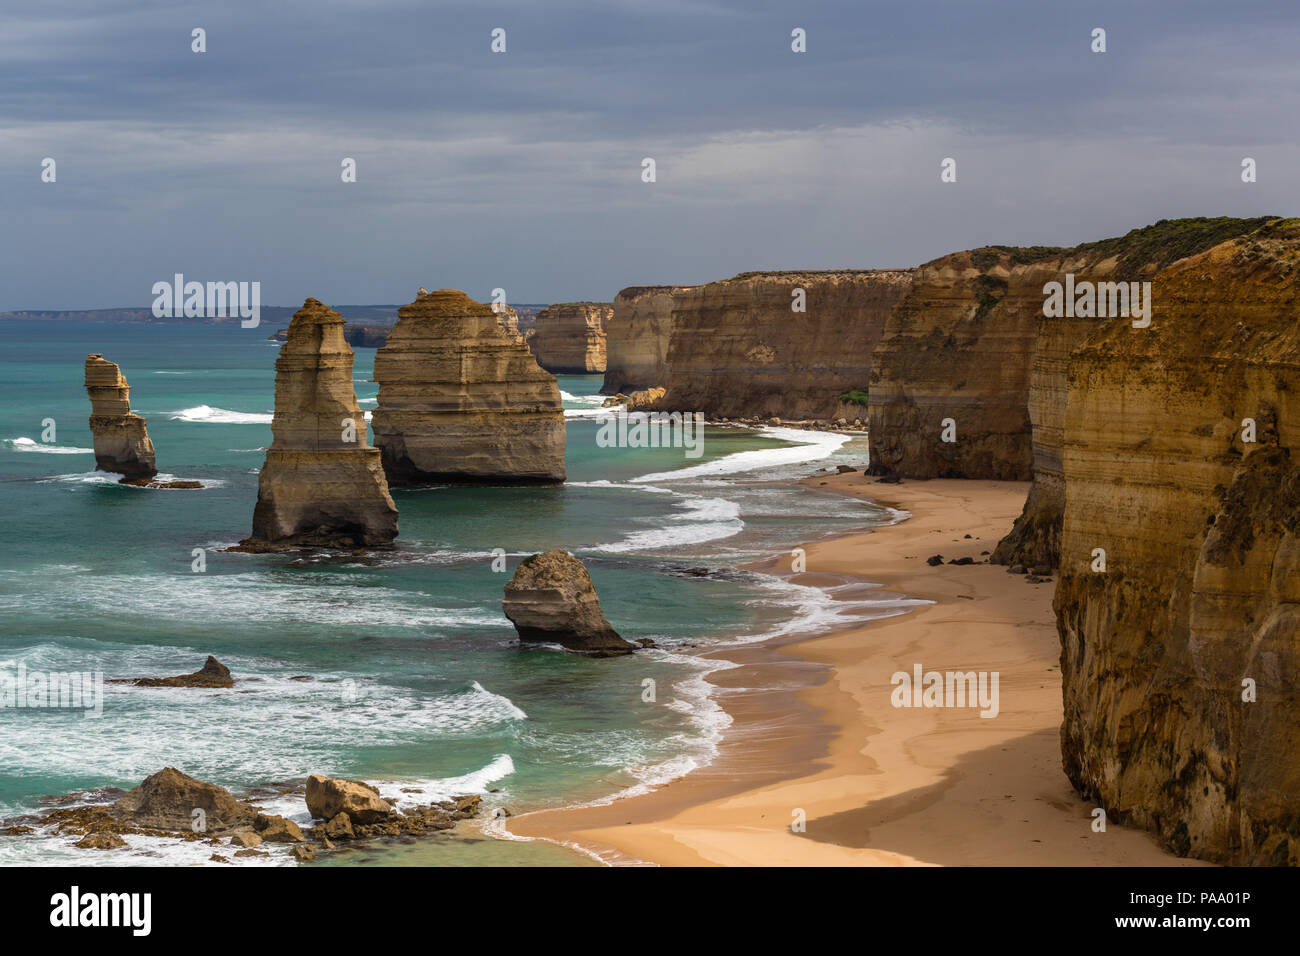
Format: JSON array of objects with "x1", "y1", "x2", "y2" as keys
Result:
[{"x1": 0, "y1": 0, "x2": 1300, "y2": 311}]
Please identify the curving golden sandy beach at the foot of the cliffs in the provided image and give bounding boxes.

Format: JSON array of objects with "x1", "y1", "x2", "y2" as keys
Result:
[{"x1": 510, "y1": 473, "x2": 1204, "y2": 866}]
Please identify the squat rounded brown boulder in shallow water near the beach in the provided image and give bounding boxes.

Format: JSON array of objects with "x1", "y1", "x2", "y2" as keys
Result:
[{"x1": 502, "y1": 549, "x2": 636, "y2": 656}]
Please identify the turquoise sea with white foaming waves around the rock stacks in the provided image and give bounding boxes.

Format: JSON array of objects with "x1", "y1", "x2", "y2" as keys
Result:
[{"x1": 0, "y1": 321, "x2": 889, "y2": 865}]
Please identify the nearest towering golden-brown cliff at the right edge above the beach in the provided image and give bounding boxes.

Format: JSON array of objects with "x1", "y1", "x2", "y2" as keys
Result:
[{"x1": 1056, "y1": 220, "x2": 1300, "y2": 865}]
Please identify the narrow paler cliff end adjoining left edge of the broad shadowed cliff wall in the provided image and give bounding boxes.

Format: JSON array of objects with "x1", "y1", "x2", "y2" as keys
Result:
[{"x1": 601, "y1": 285, "x2": 690, "y2": 395}]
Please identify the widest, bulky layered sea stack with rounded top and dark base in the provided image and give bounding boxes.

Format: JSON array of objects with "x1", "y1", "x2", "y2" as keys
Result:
[{"x1": 372, "y1": 289, "x2": 564, "y2": 484}]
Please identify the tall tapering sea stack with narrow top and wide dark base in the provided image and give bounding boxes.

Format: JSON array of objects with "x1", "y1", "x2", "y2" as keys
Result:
[{"x1": 239, "y1": 299, "x2": 398, "y2": 551}]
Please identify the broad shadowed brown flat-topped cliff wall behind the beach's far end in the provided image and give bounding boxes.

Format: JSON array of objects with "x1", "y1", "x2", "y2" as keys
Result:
[{"x1": 660, "y1": 269, "x2": 911, "y2": 420}]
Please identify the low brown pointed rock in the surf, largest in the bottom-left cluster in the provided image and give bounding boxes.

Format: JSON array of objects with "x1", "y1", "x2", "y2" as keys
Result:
[{"x1": 109, "y1": 767, "x2": 257, "y2": 834}]
